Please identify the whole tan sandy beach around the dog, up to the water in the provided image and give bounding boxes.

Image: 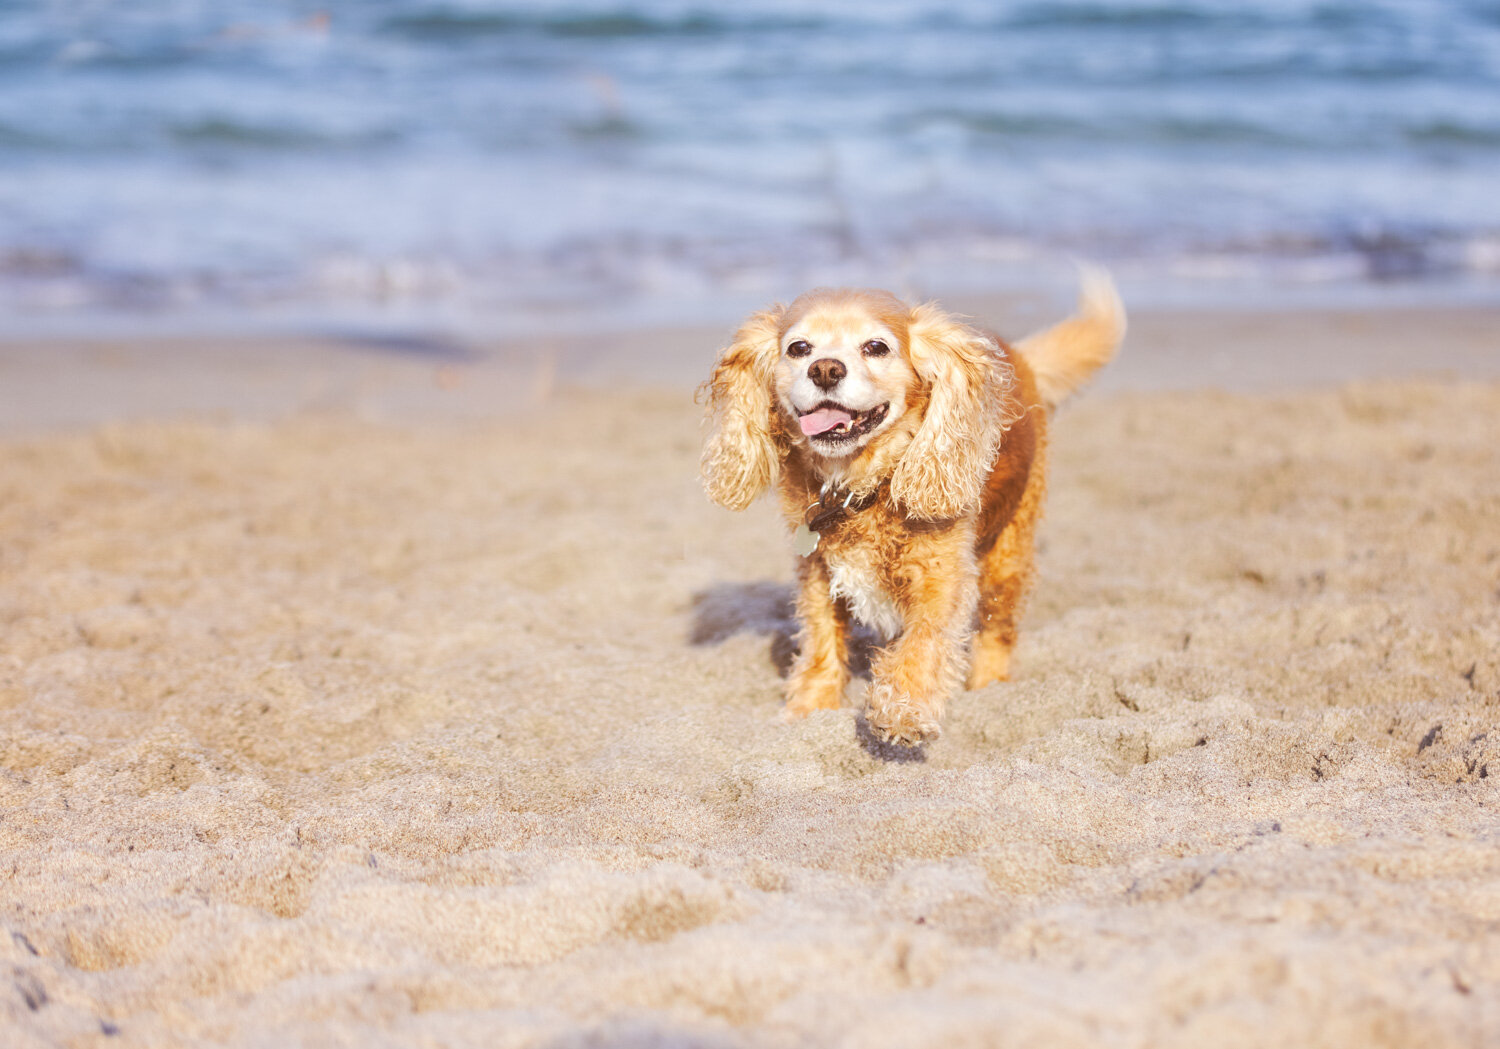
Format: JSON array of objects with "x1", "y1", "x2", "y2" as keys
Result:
[{"x1": 0, "y1": 306, "x2": 1500, "y2": 1049}]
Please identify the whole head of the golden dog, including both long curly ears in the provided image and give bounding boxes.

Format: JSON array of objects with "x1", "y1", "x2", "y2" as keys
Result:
[{"x1": 704, "y1": 288, "x2": 1016, "y2": 519}]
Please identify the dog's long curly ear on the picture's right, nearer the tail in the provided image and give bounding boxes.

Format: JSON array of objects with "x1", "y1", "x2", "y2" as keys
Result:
[{"x1": 891, "y1": 303, "x2": 1016, "y2": 521}]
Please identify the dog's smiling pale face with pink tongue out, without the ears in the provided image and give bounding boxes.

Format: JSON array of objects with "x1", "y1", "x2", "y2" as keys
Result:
[{"x1": 773, "y1": 291, "x2": 917, "y2": 459}]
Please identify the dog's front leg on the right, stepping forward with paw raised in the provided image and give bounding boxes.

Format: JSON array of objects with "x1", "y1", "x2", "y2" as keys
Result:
[{"x1": 866, "y1": 561, "x2": 978, "y2": 744}]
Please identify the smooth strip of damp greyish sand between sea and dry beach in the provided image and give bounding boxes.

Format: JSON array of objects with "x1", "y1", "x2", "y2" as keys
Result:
[{"x1": 0, "y1": 294, "x2": 1500, "y2": 437}]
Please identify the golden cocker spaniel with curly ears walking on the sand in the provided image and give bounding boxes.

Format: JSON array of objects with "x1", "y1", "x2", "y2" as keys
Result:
[{"x1": 702, "y1": 267, "x2": 1125, "y2": 746}]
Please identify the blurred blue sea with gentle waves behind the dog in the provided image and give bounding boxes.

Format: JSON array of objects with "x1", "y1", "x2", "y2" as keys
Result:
[{"x1": 0, "y1": 0, "x2": 1500, "y2": 327}]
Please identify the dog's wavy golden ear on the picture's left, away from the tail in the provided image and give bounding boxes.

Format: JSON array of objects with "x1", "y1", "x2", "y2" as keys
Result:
[{"x1": 699, "y1": 305, "x2": 786, "y2": 510}]
